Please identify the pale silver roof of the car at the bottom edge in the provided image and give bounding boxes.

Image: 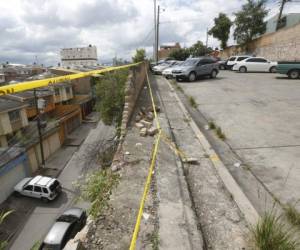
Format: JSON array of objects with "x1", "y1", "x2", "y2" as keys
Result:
[{"x1": 44, "y1": 221, "x2": 71, "y2": 245}]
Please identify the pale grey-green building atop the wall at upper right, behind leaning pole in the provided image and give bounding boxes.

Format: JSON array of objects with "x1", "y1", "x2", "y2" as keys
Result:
[{"x1": 265, "y1": 13, "x2": 300, "y2": 34}]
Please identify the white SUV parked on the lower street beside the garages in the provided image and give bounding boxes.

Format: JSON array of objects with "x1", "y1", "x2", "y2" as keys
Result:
[{"x1": 14, "y1": 175, "x2": 61, "y2": 202}]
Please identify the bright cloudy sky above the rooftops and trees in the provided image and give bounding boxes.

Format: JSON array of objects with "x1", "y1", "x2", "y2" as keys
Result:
[{"x1": 0, "y1": 0, "x2": 300, "y2": 66}]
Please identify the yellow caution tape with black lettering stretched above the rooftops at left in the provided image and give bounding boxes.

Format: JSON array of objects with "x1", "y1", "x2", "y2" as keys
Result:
[{"x1": 0, "y1": 63, "x2": 140, "y2": 96}]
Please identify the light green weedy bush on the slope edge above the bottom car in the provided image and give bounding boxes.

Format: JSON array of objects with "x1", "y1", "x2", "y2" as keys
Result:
[{"x1": 81, "y1": 169, "x2": 120, "y2": 218}]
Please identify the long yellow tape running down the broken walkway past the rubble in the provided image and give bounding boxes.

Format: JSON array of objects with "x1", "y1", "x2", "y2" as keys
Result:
[{"x1": 129, "y1": 69, "x2": 162, "y2": 250}]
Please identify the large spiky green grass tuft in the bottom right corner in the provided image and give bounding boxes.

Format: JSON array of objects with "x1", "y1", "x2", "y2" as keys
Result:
[{"x1": 252, "y1": 213, "x2": 299, "y2": 250}]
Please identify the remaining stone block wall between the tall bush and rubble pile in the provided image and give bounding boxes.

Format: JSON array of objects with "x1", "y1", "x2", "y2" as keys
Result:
[{"x1": 121, "y1": 63, "x2": 148, "y2": 137}]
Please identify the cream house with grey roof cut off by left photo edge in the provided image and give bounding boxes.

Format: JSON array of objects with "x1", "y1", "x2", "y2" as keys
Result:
[{"x1": 0, "y1": 97, "x2": 28, "y2": 147}]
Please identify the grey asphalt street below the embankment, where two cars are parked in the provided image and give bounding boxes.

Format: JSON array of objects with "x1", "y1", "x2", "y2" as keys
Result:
[{"x1": 10, "y1": 122, "x2": 114, "y2": 250}]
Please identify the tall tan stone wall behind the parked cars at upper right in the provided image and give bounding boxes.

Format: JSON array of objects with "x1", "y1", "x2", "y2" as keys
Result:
[{"x1": 220, "y1": 24, "x2": 300, "y2": 61}]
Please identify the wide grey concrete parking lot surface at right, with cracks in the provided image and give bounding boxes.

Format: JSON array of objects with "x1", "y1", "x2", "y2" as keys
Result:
[{"x1": 179, "y1": 71, "x2": 300, "y2": 215}]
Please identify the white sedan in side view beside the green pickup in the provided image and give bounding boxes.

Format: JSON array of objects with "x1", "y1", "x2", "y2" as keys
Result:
[{"x1": 232, "y1": 57, "x2": 277, "y2": 73}]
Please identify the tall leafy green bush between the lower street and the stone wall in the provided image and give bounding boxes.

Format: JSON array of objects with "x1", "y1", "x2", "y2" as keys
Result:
[{"x1": 94, "y1": 70, "x2": 128, "y2": 127}]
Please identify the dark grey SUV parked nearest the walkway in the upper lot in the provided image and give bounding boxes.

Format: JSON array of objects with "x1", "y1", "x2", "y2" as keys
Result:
[{"x1": 172, "y1": 57, "x2": 219, "y2": 82}]
